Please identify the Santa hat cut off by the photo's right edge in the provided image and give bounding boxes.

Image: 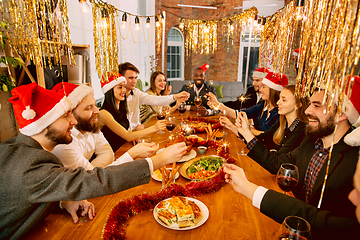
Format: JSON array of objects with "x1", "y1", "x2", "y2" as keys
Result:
[{"x1": 344, "y1": 76, "x2": 360, "y2": 146}]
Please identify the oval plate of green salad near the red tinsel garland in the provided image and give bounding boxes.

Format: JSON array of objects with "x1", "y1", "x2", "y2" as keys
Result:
[{"x1": 180, "y1": 155, "x2": 226, "y2": 180}]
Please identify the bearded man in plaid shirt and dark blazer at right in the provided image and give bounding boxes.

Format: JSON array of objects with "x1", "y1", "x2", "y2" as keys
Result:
[{"x1": 224, "y1": 90, "x2": 360, "y2": 239}]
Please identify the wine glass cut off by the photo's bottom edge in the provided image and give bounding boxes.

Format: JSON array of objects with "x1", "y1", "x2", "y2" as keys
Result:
[{"x1": 278, "y1": 216, "x2": 311, "y2": 240}]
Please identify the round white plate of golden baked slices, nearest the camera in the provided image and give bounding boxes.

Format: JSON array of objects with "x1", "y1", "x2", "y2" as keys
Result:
[{"x1": 153, "y1": 196, "x2": 209, "y2": 230}]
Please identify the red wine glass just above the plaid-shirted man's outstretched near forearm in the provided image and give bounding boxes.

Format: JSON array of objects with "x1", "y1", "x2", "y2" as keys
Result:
[{"x1": 276, "y1": 163, "x2": 299, "y2": 194}]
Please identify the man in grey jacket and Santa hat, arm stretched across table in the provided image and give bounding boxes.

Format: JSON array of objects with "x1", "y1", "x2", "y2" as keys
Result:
[{"x1": 0, "y1": 83, "x2": 186, "y2": 239}]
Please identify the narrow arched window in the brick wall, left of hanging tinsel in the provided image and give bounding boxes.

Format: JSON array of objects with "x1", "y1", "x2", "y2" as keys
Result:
[{"x1": 167, "y1": 28, "x2": 184, "y2": 80}]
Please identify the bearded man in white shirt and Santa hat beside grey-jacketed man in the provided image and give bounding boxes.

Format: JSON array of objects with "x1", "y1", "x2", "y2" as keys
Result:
[{"x1": 52, "y1": 82, "x2": 158, "y2": 170}]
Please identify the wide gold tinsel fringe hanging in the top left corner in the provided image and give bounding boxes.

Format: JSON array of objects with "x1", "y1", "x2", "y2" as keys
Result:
[{"x1": 0, "y1": 0, "x2": 75, "y2": 71}]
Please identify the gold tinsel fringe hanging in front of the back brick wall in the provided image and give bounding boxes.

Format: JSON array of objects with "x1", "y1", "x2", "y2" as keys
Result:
[{"x1": 180, "y1": 7, "x2": 258, "y2": 56}]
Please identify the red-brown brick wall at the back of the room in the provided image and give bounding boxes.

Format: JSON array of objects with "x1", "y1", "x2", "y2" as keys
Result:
[{"x1": 155, "y1": 0, "x2": 295, "y2": 84}]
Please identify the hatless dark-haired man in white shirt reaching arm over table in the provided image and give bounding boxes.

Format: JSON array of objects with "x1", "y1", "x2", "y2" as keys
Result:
[{"x1": 119, "y1": 62, "x2": 189, "y2": 130}]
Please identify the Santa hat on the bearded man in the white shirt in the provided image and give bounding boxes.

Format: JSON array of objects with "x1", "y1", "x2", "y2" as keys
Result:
[{"x1": 52, "y1": 82, "x2": 94, "y2": 109}]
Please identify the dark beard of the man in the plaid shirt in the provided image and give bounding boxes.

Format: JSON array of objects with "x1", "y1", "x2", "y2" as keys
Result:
[{"x1": 305, "y1": 114, "x2": 335, "y2": 139}]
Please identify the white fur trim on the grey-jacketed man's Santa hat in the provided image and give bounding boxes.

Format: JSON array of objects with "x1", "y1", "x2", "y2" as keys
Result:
[{"x1": 19, "y1": 97, "x2": 71, "y2": 136}]
